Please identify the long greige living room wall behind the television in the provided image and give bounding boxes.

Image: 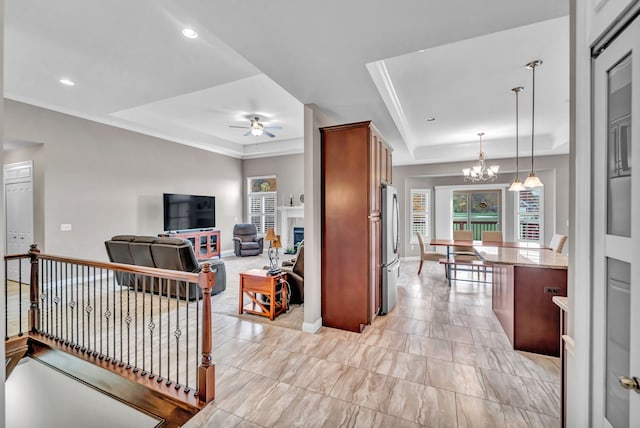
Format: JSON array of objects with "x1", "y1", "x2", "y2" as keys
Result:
[{"x1": 5, "y1": 100, "x2": 243, "y2": 260}]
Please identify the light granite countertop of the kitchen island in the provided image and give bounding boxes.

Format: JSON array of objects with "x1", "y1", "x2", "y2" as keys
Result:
[{"x1": 473, "y1": 245, "x2": 569, "y2": 269}]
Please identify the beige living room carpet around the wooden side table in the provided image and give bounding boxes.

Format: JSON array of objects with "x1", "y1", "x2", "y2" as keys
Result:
[{"x1": 211, "y1": 253, "x2": 304, "y2": 330}]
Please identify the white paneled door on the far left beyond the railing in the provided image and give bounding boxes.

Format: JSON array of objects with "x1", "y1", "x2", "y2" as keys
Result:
[{"x1": 4, "y1": 162, "x2": 33, "y2": 283}]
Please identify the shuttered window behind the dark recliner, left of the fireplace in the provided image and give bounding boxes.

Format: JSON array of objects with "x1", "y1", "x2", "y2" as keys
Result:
[{"x1": 247, "y1": 175, "x2": 277, "y2": 233}]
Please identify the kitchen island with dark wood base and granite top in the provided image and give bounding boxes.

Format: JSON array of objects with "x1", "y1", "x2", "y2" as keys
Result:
[{"x1": 474, "y1": 246, "x2": 568, "y2": 357}]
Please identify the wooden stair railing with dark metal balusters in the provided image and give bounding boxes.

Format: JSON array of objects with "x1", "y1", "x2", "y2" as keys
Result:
[{"x1": 5, "y1": 245, "x2": 215, "y2": 409}]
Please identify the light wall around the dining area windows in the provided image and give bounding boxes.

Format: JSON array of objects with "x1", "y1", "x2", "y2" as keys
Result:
[{"x1": 393, "y1": 155, "x2": 571, "y2": 257}]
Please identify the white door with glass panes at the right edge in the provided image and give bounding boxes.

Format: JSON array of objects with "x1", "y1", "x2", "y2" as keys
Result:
[{"x1": 591, "y1": 13, "x2": 640, "y2": 428}]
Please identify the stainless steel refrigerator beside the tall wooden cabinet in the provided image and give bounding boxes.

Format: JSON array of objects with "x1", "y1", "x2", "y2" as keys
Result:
[{"x1": 380, "y1": 185, "x2": 400, "y2": 315}]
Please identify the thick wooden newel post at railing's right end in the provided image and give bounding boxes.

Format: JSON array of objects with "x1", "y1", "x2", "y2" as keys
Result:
[{"x1": 198, "y1": 263, "x2": 216, "y2": 403}]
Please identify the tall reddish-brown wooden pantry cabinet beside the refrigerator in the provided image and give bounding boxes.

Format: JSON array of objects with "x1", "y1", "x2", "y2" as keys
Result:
[{"x1": 320, "y1": 121, "x2": 391, "y2": 332}]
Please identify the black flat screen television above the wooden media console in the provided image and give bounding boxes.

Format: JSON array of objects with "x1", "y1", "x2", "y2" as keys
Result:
[{"x1": 163, "y1": 193, "x2": 216, "y2": 231}]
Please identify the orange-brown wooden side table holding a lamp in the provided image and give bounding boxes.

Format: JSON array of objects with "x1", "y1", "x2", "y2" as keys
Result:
[{"x1": 238, "y1": 269, "x2": 287, "y2": 321}]
